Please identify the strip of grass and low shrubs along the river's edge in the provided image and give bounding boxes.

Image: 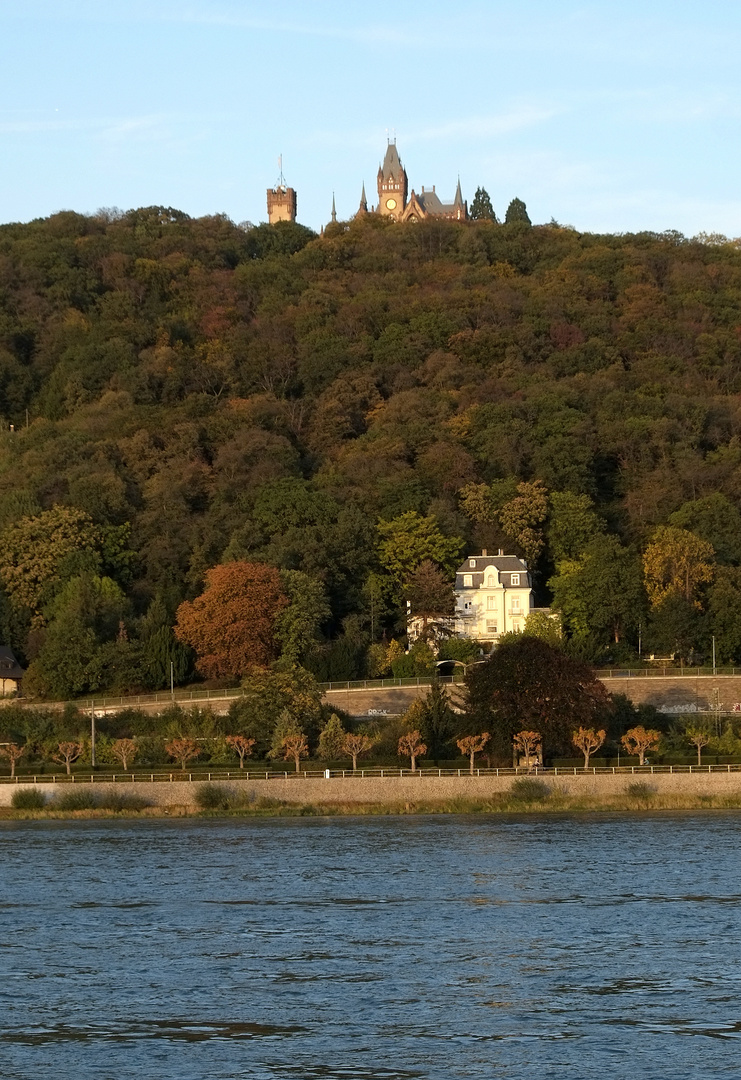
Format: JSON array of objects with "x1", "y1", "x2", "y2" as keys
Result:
[{"x1": 0, "y1": 780, "x2": 741, "y2": 821}]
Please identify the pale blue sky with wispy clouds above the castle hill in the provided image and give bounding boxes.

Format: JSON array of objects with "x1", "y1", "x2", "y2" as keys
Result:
[{"x1": 0, "y1": 0, "x2": 741, "y2": 238}]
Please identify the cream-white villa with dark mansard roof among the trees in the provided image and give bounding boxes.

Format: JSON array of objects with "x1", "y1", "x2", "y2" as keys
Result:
[{"x1": 453, "y1": 550, "x2": 534, "y2": 646}]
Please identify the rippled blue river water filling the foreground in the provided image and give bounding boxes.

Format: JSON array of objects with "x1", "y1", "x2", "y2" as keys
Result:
[{"x1": 0, "y1": 814, "x2": 741, "y2": 1080}]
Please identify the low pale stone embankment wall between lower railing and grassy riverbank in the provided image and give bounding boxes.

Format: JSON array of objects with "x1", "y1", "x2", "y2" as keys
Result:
[{"x1": 0, "y1": 769, "x2": 741, "y2": 807}]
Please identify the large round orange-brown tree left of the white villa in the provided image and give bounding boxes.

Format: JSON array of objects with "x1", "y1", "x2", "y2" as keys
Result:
[{"x1": 175, "y1": 562, "x2": 288, "y2": 678}]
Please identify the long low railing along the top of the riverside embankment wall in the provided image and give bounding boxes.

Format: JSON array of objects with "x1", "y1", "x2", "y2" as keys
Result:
[{"x1": 0, "y1": 762, "x2": 741, "y2": 784}]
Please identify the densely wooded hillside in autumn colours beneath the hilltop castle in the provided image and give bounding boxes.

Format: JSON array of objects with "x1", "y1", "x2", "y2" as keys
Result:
[{"x1": 0, "y1": 201, "x2": 741, "y2": 689}]
